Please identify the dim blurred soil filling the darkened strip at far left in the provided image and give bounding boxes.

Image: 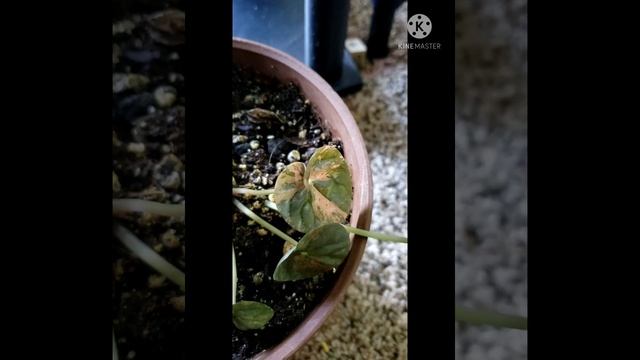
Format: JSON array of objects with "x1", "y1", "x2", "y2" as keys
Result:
[{"x1": 112, "y1": 10, "x2": 185, "y2": 359}]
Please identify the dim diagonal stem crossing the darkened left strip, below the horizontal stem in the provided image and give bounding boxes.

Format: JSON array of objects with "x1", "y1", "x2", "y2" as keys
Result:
[{"x1": 113, "y1": 224, "x2": 185, "y2": 291}]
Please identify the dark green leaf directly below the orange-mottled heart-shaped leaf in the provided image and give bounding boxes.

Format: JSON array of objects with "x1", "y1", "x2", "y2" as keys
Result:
[{"x1": 273, "y1": 224, "x2": 351, "y2": 281}]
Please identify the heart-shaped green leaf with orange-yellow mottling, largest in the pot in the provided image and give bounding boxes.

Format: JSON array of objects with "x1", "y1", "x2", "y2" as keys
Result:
[{"x1": 274, "y1": 146, "x2": 353, "y2": 233}]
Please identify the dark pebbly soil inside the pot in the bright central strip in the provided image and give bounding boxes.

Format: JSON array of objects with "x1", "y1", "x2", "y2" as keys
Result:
[{"x1": 230, "y1": 67, "x2": 342, "y2": 360}]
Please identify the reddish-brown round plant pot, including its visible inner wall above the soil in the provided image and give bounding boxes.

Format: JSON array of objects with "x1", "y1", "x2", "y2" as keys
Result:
[{"x1": 233, "y1": 38, "x2": 373, "y2": 360}]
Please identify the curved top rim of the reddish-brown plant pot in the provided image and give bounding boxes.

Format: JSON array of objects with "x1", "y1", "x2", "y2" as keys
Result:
[{"x1": 232, "y1": 37, "x2": 373, "y2": 360}]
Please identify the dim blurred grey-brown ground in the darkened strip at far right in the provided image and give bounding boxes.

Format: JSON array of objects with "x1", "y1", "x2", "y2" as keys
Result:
[{"x1": 456, "y1": 0, "x2": 527, "y2": 360}]
